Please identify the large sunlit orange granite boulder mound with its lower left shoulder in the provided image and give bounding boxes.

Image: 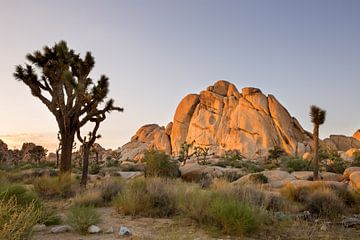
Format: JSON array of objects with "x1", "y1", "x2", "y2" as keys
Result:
[{"x1": 121, "y1": 80, "x2": 311, "y2": 158}]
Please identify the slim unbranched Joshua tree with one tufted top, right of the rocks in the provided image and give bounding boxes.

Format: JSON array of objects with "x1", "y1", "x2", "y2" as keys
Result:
[{"x1": 310, "y1": 105, "x2": 326, "y2": 180}]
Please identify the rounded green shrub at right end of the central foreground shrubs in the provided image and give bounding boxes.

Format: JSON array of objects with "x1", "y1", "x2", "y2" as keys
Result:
[{"x1": 208, "y1": 196, "x2": 261, "y2": 234}]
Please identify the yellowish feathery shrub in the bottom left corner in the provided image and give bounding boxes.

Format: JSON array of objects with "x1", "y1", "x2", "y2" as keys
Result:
[{"x1": 0, "y1": 196, "x2": 39, "y2": 240}]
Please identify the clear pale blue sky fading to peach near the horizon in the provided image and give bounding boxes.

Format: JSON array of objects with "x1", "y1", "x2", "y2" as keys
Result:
[{"x1": 0, "y1": 0, "x2": 360, "y2": 150}]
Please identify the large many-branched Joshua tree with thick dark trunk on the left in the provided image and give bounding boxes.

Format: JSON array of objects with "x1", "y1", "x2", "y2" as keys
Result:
[{"x1": 14, "y1": 41, "x2": 119, "y2": 173}]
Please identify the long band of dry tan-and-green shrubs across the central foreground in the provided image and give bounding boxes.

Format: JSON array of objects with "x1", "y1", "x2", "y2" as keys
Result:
[{"x1": 113, "y1": 178, "x2": 264, "y2": 234}]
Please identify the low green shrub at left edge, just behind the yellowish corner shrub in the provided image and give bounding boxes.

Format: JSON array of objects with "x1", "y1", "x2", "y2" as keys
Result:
[{"x1": 0, "y1": 184, "x2": 41, "y2": 208}]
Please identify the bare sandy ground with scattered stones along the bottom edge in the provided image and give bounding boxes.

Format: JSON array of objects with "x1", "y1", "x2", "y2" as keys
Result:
[{"x1": 32, "y1": 208, "x2": 360, "y2": 240}]
